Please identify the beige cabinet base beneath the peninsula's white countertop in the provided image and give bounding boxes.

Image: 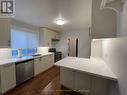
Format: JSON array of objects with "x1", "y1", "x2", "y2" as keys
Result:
[{"x1": 60, "y1": 67, "x2": 108, "y2": 95}]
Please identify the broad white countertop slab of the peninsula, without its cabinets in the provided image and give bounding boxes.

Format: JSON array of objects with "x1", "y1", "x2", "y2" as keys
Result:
[{"x1": 55, "y1": 57, "x2": 117, "y2": 80}]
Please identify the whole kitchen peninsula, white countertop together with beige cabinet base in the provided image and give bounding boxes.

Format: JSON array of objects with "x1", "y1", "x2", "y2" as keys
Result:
[{"x1": 55, "y1": 57, "x2": 117, "y2": 95}]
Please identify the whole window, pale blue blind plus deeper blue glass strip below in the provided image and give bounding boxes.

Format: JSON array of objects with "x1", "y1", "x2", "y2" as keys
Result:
[{"x1": 11, "y1": 29, "x2": 38, "y2": 57}]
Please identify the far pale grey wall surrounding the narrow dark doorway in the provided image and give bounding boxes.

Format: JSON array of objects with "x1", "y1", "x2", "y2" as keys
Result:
[{"x1": 56, "y1": 29, "x2": 91, "y2": 58}]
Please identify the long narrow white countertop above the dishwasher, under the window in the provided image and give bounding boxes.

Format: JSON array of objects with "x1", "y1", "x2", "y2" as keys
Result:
[{"x1": 0, "y1": 53, "x2": 53, "y2": 66}]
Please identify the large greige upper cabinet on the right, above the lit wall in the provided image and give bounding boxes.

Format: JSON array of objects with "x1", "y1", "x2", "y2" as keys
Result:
[{"x1": 91, "y1": 0, "x2": 117, "y2": 38}]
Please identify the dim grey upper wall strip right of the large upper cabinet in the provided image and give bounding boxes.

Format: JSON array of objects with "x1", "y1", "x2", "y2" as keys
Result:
[{"x1": 117, "y1": 0, "x2": 127, "y2": 37}]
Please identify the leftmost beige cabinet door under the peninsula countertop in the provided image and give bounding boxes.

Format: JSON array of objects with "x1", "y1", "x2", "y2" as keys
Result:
[{"x1": 60, "y1": 68, "x2": 75, "y2": 90}]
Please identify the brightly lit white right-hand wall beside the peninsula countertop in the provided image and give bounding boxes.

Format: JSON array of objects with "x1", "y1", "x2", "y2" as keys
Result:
[{"x1": 102, "y1": 38, "x2": 127, "y2": 95}]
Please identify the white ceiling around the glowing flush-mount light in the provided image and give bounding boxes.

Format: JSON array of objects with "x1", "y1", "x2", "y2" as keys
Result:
[{"x1": 15, "y1": 0, "x2": 92, "y2": 31}]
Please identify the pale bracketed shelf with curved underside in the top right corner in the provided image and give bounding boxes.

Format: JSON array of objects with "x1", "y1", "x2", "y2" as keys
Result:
[{"x1": 100, "y1": 0, "x2": 125, "y2": 13}]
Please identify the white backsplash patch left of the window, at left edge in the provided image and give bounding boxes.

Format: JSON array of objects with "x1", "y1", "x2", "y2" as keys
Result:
[{"x1": 0, "y1": 48, "x2": 12, "y2": 60}]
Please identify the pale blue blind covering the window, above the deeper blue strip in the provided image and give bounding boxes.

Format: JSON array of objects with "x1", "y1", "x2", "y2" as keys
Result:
[{"x1": 11, "y1": 29, "x2": 38, "y2": 49}]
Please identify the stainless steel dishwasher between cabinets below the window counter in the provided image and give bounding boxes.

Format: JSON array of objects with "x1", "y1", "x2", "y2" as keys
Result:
[{"x1": 16, "y1": 60, "x2": 34, "y2": 85}]
